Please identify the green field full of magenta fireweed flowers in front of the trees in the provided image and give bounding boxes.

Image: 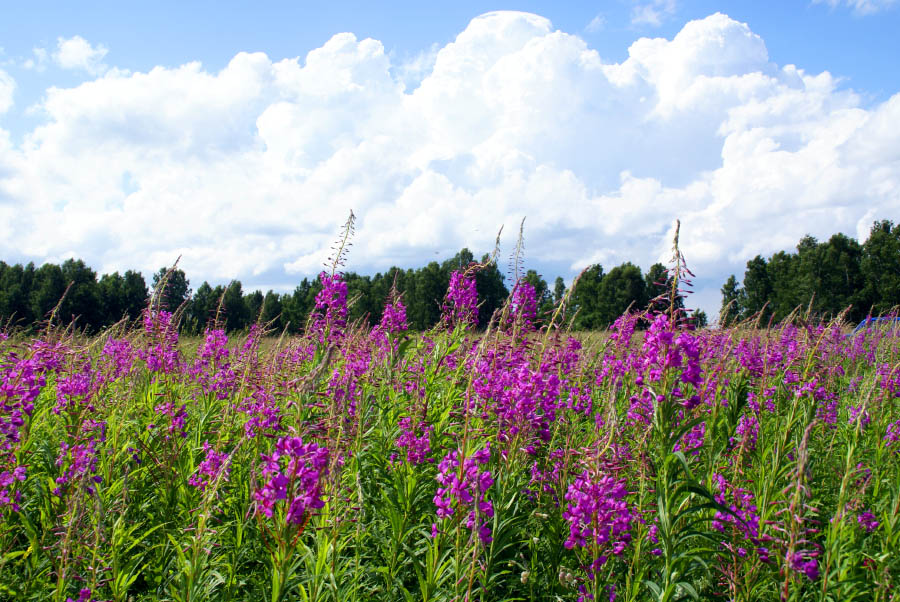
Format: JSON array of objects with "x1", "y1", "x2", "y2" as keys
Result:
[{"x1": 0, "y1": 273, "x2": 900, "y2": 602}]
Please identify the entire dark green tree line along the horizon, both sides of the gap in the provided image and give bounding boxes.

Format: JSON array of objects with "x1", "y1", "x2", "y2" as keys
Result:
[{"x1": 0, "y1": 221, "x2": 900, "y2": 334}]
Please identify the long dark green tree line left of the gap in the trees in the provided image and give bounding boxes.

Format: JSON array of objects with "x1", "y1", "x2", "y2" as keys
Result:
[{"x1": 0, "y1": 249, "x2": 705, "y2": 334}]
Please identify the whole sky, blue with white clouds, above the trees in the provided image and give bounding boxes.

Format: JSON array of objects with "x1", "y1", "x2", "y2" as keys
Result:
[{"x1": 0, "y1": 0, "x2": 900, "y2": 315}]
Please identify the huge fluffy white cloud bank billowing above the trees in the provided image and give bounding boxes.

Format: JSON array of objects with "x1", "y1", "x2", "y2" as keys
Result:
[{"x1": 0, "y1": 12, "x2": 900, "y2": 311}]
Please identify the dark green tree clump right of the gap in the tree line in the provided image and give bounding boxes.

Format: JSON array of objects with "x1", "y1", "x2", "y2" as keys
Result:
[{"x1": 720, "y1": 220, "x2": 900, "y2": 324}]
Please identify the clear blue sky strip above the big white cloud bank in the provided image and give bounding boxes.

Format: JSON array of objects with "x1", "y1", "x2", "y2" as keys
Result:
[{"x1": 0, "y1": 0, "x2": 900, "y2": 99}]
